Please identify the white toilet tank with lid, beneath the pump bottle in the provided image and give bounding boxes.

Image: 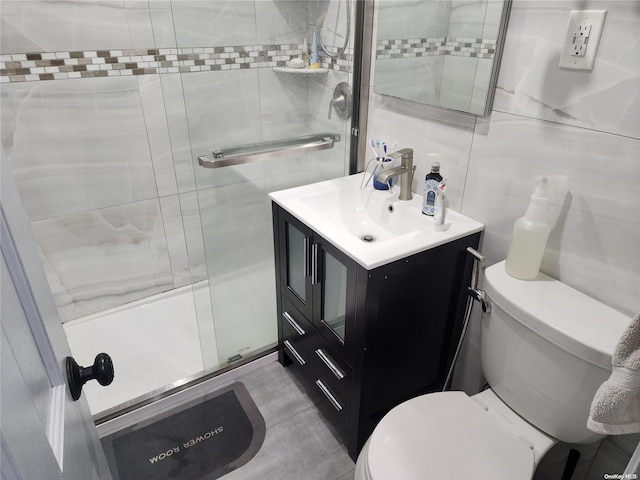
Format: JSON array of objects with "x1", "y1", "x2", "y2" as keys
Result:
[{"x1": 480, "y1": 262, "x2": 631, "y2": 443}]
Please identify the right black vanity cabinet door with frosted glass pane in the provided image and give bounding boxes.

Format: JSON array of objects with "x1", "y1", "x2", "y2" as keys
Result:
[{"x1": 312, "y1": 237, "x2": 357, "y2": 365}]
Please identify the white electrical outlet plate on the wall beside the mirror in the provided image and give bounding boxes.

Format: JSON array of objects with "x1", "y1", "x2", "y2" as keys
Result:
[{"x1": 560, "y1": 10, "x2": 607, "y2": 70}]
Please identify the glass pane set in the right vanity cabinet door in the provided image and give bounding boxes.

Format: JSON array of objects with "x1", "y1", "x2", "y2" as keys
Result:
[{"x1": 322, "y1": 251, "x2": 347, "y2": 342}]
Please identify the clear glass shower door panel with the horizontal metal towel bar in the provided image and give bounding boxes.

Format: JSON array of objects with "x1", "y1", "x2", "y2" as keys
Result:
[{"x1": 150, "y1": 0, "x2": 353, "y2": 371}]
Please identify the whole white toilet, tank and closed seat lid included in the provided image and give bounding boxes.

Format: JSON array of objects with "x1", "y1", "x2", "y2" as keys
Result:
[{"x1": 355, "y1": 262, "x2": 630, "y2": 480}]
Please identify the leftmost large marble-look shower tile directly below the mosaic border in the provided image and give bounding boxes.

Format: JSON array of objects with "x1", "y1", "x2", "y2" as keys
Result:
[{"x1": 1, "y1": 78, "x2": 157, "y2": 220}]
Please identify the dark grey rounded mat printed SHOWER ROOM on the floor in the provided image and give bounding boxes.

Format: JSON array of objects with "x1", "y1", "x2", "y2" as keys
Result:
[{"x1": 101, "y1": 382, "x2": 265, "y2": 480}]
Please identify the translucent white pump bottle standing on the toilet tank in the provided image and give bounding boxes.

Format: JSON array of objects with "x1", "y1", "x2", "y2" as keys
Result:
[{"x1": 505, "y1": 177, "x2": 551, "y2": 280}]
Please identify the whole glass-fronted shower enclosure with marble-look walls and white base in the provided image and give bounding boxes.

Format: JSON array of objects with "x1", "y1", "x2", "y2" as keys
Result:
[{"x1": 0, "y1": 0, "x2": 355, "y2": 418}]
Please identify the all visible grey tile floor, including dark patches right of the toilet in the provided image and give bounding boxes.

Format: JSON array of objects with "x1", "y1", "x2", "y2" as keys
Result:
[{"x1": 98, "y1": 354, "x2": 640, "y2": 480}]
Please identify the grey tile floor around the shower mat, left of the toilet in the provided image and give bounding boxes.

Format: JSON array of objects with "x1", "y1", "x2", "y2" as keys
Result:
[{"x1": 98, "y1": 356, "x2": 355, "y2": 480}]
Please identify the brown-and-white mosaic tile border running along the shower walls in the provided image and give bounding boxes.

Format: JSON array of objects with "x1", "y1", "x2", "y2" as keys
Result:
[{"x1": 0, "y1": 44, "x2": 353, "y2": 83}]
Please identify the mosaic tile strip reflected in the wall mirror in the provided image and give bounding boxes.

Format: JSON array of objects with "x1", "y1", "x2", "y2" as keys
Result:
[{"x1": 376, "y1": 37, "x2": 496, "y2": 60}]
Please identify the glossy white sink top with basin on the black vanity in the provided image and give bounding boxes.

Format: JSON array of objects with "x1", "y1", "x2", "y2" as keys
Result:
[{"x1": 270, "y1": 173, "x2": 484, "y2": 270}]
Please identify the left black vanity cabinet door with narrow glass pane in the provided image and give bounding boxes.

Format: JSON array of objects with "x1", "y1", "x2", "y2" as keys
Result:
[{"x1": 278, "y1": 210, "x2": 313, "y2": 319}]
